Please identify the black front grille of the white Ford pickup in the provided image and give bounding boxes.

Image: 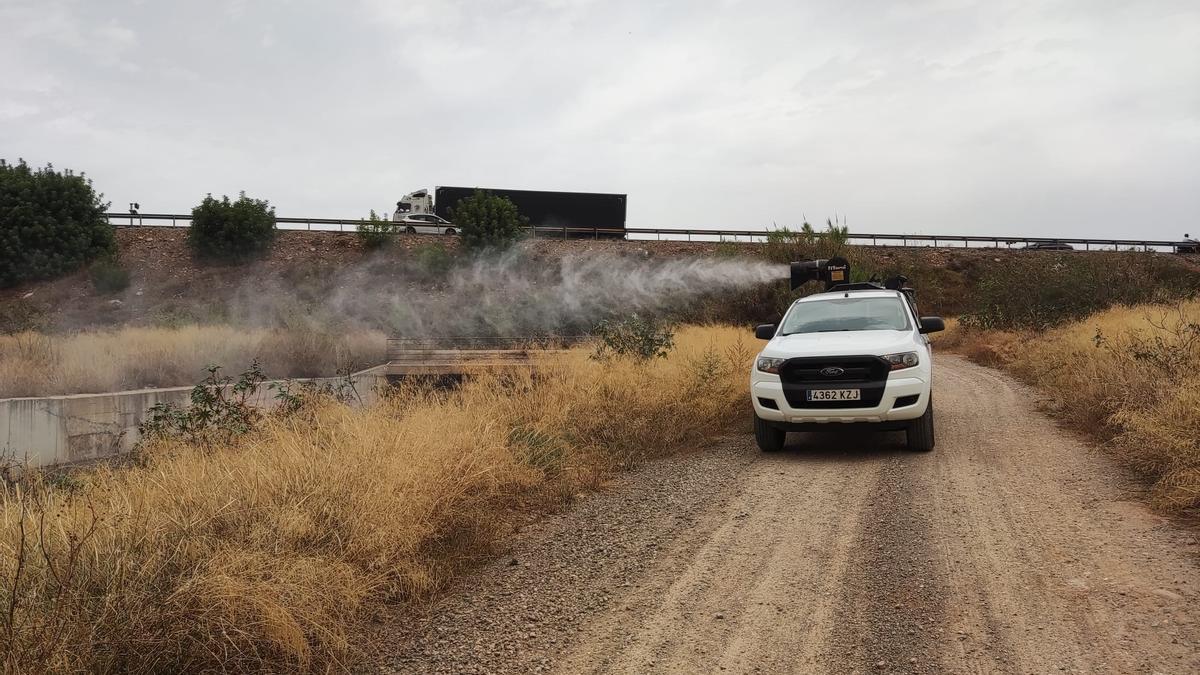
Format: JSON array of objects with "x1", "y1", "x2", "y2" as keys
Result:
[{"x1": 779, "y1": 356, "x2": 892, "y2": 408}]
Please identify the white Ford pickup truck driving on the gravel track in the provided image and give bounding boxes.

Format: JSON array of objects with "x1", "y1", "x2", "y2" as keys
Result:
[{"x1": 750, "y1": 283, "x2": 944, "y2": 452}]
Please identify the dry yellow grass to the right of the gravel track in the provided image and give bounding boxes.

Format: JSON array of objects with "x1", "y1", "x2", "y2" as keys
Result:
[{"x1": 937, "y1": 301, "x2": 1200, "y2": 509}]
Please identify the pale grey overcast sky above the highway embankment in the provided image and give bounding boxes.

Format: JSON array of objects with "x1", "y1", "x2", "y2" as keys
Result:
[{"x1": 0, "y1": 0, "x2": 1200, "y2": 238}]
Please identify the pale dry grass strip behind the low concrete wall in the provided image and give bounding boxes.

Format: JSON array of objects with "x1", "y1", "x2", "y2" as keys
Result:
[{"x1": 0, "y1": 325, "x2": 385, "y2": 399}]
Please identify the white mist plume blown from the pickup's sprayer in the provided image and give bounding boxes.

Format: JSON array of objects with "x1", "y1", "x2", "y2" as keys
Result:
[{"x1": 238, "y1": 250, "x2": 788, "y2": 338}]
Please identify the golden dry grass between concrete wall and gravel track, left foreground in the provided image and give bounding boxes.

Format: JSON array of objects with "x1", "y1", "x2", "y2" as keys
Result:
[{"x1": 0, "y1": 328, "x2": 752, "y2": 673}]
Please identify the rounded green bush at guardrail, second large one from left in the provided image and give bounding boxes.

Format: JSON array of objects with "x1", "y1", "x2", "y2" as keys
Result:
[{"x1": 187, "y1": 192, "x2": 275, "y2": 262}]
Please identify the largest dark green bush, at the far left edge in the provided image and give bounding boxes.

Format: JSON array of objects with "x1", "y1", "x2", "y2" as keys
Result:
[{"x1": 0, "y1": 160, "x2": 116, "y2": 287}]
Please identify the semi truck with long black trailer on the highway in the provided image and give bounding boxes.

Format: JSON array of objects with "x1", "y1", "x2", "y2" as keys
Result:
[{"x1": 392, "y1": 185, "x2": 628, "y2": 239}]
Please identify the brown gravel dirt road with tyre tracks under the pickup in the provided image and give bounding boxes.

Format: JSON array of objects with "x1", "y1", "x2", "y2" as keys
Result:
[{"x1": 374, "y1": 356, "x2": 1200, "y2": 674}]
